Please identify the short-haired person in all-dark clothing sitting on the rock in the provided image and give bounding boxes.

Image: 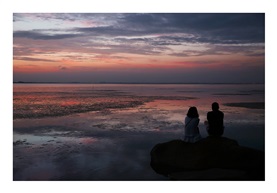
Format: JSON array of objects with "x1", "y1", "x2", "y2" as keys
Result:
[{"x1": 205, "y1": 102, "x2": 224, "y2": 136}]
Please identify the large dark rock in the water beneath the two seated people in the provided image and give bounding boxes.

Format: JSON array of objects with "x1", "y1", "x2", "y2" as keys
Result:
[{"x1": 151, "y1": 137, "x2": 265, "y2": 180}]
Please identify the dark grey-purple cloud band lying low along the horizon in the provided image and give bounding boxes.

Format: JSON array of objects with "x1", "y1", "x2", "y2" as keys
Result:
[{"x1": 13, "y1": 63, "x2": 265, "y2": 83}]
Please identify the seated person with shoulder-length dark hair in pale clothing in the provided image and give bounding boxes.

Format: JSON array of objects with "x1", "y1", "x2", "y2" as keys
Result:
[{"x1": 184, "y1": 107, "x2": 201, "y2": 143}]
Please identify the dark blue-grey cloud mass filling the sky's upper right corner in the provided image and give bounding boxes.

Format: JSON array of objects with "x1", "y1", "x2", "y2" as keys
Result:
[{"x1": 118, "y1": 13, "x2": 265, "y2": 43}]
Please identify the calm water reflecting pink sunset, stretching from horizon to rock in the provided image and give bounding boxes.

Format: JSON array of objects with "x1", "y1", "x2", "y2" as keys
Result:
[{"x1": 13, "y1": 84, "x2": 265, "y2": 180}]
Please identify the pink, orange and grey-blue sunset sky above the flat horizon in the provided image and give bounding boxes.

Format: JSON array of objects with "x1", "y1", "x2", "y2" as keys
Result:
[{"x1": 13, "y1": 13, "x2": 265, "y2": 83}]
